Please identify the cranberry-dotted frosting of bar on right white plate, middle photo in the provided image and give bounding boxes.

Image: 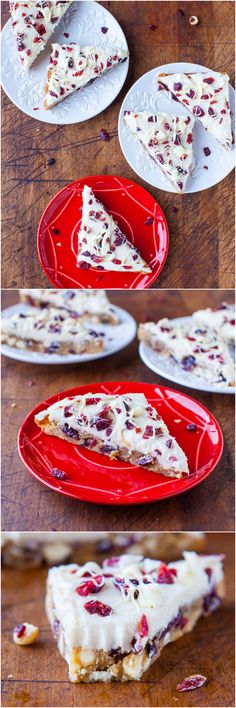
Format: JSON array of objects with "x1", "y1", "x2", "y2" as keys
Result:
[{"x1": 140, "y1": 318, "x2": 235, "y2": 385}]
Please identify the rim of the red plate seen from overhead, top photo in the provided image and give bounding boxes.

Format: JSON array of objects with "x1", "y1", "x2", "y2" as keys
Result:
[{"x1": 37, "y1": 174, "x2": 169, "y2": 290}]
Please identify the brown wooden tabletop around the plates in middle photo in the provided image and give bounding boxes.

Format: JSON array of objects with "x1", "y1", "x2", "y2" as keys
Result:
[{"x1": 2, "y1": 290, "x2": 234, "y2": 531}]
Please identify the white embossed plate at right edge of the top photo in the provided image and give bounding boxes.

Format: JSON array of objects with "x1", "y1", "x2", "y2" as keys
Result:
[{"x1": 118, "y1": 62, "x2": 235, "y2": 194}]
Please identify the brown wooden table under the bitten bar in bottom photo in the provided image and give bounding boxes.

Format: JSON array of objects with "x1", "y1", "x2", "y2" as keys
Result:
[{"x1": 2, "y1": 533, "x2": 234, "y2": 708}]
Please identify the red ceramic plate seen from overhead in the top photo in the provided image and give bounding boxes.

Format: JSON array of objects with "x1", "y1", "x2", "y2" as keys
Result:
[{"x1": 38, "y1": 175, "x2": 169, "y2": 289}]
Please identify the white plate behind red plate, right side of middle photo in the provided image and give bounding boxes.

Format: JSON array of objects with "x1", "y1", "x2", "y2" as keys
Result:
[{"x1": 139, "y1": 317, "x2": 235, "y2": 394}]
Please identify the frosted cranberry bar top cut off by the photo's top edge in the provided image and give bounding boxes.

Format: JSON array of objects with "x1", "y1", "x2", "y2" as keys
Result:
[{"x1": 10, "y1": 0, "x2": 72, "y2": 70}]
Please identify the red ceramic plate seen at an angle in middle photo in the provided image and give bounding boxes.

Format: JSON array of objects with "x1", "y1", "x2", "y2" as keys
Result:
[{"x1": 18, "y1": 381, "x2": 223, "y2": 504}]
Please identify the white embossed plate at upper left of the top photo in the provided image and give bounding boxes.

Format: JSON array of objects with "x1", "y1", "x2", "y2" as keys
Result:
[{"x1": 2, "y1": 0, "x2": 129, "y2": 127}]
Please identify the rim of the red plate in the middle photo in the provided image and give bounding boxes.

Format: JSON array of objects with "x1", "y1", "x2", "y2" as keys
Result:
[{"x1": 17, "y1": 381, "x2": 224, "y2": 506}]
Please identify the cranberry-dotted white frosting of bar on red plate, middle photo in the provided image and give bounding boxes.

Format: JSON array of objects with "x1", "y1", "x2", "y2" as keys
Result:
[{"x1": 35, "y1": 393, "x2": 188, "y2": 476}]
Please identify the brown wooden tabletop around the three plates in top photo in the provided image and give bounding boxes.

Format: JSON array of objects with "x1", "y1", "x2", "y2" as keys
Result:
[{"x1": 2, "y1": 0, "x2": 235, "y2": 288}]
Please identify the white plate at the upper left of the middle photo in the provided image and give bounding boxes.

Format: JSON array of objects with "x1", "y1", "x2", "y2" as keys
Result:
[{"x1": 1, "y1": 303, "x2": 137, "y2": 364}]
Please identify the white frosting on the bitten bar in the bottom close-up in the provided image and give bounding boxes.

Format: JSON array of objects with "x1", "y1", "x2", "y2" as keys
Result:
[{"x1": 48, "y1": 552, "x2": 223, "y2": 652}]
